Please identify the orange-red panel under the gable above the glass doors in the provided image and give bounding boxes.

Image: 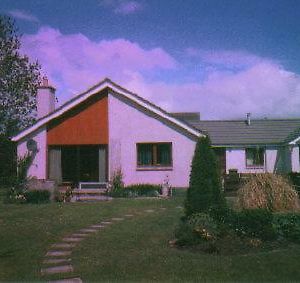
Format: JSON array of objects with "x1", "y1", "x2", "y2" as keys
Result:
[{"x1": 47, "y1": 95, "x2": 108, "y2": 145}]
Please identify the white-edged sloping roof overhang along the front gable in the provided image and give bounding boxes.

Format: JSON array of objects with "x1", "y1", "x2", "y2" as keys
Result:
[{"x1": 12, "y1": 79, "x2": 204, "y2": 142}]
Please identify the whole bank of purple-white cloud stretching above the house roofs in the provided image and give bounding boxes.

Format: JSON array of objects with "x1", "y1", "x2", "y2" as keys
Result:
[{"x1": 19, "y1": 27, "x2": 300, "y2": 119}]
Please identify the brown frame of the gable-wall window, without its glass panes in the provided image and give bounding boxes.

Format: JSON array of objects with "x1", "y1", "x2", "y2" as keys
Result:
[{"x1": 136, "y1": 142, "x2": 173, "y2": 171}]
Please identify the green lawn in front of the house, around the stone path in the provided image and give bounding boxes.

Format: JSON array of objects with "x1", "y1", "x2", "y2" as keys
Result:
[{"x1": 0, "y1": 190, "x2": 300, "y2": 282}]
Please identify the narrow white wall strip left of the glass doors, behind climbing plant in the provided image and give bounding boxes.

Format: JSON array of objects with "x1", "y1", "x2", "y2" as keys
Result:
[{"x1": 18, "y1": 127, "x2": 47, "y2": 179}]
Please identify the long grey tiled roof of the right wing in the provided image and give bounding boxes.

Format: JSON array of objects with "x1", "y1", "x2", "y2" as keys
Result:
[{"x1": 189, "y1": 119, "x2": 300, "y2": 146}]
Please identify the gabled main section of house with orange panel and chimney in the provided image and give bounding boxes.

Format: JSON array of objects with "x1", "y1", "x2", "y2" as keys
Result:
[{"x1": 12, "y1": 79, "x2": 202, "y2": 187}]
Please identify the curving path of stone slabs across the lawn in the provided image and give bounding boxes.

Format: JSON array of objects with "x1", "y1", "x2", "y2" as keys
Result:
[{"x1": 41, "y1": 207, "x2": 166, "y2": 283}]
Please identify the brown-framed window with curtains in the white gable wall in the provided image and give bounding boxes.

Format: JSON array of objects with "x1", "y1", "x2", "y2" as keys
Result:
[{"x1": 137, "y1": 143, "x2": 172, "y2": 167}]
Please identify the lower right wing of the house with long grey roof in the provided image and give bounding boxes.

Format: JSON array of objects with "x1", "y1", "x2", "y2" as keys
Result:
[{"x1": 174, "y1": 113, "x2": 300, "y2": 174}]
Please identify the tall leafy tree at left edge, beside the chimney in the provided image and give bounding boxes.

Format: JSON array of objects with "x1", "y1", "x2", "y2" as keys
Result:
[{"x1": 0, "y1": 15, "x2": 41, "y2": 137}]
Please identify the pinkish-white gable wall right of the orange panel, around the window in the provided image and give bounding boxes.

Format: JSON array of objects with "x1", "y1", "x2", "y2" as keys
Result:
[{"x1": 108, "y1": 94, "x2": 195, "y2": 187}]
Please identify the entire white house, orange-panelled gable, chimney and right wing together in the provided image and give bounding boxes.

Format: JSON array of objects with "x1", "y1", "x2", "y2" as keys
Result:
[{"x1": 12, "y1": 79, "x2": 300, "y2": 187}]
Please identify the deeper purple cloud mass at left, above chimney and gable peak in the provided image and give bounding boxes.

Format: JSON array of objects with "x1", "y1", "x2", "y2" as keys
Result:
[{"x1": 22, "y1": 27, "x2": 177, "y2": 101}]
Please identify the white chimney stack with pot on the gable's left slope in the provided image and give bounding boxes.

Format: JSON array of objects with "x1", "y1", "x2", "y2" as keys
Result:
[{"x1": 37, "y1": 76, "x2": 55, "y2": 119}]
